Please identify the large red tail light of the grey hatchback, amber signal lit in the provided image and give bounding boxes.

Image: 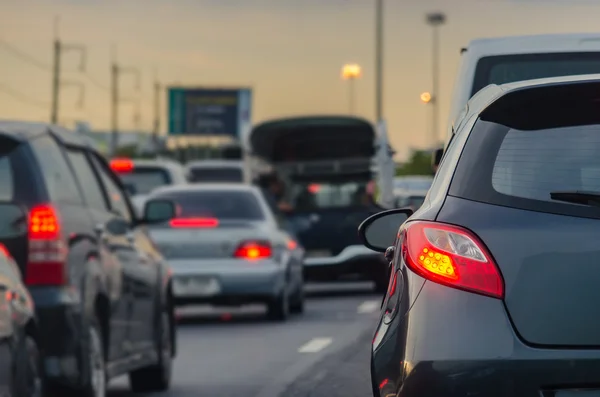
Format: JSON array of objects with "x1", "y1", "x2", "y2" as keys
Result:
[{"x1": 402, "y1": 221, "x2": 504, "y2": 299}]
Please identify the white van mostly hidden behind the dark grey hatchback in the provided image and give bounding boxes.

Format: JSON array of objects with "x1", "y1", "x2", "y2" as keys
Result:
[{"x1": 446, "y1": 34, "x2": 600, "y2": 144}]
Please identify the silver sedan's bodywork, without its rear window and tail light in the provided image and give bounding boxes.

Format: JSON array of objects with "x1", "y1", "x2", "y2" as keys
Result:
[{"x1": 144, "y1": 184, "x2": 304, "y2": 305}]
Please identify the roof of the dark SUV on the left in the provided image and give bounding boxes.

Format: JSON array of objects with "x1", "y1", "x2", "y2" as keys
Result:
[{"x1": 0, "y1": 120, "x2": 94, "y2": 150}]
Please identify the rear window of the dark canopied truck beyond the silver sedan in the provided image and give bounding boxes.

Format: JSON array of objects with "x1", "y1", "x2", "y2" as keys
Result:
[{"x1": 292, "y1": 182, "x2": 371, "y2": 211}]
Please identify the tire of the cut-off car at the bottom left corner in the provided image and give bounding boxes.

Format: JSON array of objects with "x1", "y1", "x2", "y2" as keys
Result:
[{"x1": 13, "y1": 335, "x2": 42, "y2": 397}]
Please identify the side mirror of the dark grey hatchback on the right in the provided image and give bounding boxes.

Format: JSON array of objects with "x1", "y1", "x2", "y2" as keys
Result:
[{"x1": 358, "y1": 208, "x2": 413, "y2": 252}]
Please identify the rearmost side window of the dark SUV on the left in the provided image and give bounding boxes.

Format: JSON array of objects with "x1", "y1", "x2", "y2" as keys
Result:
[{"x1": 31, "y1": 136, "x2": 82, "y2": 203}]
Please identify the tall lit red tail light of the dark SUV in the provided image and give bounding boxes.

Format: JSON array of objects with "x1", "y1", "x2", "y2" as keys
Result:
[{"x1": 25, "y1": 205, "x2": 67, "y2": 285}]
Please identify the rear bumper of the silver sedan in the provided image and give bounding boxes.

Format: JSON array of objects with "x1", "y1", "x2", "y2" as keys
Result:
[{"x1": 169, "y1": 259, "x2": 286, "y2": 305}]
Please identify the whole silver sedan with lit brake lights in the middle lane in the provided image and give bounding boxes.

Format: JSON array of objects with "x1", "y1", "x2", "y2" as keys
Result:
[{"x1": 143, "y1": 183, "x2": 304, "y2": 320}]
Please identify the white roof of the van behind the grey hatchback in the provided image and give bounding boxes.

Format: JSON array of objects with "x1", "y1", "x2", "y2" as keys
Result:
[{"x1": 467, "y1": 33, "x2": 600, "y2": 57}]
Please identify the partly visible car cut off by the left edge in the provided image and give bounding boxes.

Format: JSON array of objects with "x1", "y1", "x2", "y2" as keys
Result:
[{"x1": 0, "y1": 241, "x2": 42, "y2": 397}]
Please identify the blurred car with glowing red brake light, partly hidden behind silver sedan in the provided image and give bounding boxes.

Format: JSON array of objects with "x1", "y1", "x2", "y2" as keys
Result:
[{"x1": 110, "y1": 158, "x2": 187, "y2": 214}]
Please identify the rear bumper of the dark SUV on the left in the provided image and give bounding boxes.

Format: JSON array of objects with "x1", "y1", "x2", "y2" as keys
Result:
[{"x1": 29, "y1": 287, "x2": 83, "y2": 385}]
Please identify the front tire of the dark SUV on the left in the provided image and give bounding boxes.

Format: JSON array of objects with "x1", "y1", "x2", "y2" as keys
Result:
[{"x1": 129, "y1": 308, "x2": 173, "y2": 393}]
